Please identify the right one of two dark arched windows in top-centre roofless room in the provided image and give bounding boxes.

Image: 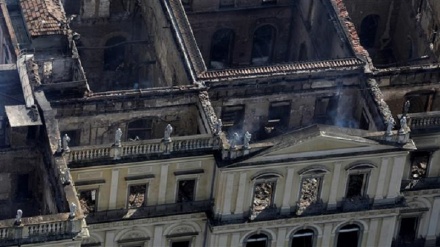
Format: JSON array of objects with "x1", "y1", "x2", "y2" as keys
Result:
[{"x1": 251, "y1": 25, "x2": 275, "y2": 65}]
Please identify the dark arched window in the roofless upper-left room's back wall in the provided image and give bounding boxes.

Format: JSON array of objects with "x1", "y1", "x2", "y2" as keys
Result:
[{"x1": 104, "y1": 36, "x2": 126, "y2": 71}]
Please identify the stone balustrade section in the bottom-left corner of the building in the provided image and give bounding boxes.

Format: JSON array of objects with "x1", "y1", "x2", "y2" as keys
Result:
[{"x1": 0, "y1": 213, "x2": 82, "y2": 246}]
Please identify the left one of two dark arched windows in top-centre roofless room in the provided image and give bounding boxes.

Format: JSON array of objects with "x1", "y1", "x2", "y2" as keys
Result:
[{"x1": 210, "y1": 29, "x2": 235, "y2": 69}]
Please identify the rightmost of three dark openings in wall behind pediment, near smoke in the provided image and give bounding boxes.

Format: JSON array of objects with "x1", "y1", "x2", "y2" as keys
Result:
[{"x1": 315, "y1": 96, "x2": 339, "y2": 125}]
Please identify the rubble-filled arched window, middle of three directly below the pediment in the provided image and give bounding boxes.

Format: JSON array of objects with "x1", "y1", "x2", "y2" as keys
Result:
[{"x1": 296, "y1": 177, "x2": 322, "y2": 215}]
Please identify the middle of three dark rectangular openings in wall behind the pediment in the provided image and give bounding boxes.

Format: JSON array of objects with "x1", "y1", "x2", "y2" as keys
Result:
[{"x1": 266, "y1": 101, "x2": 291, "y2": 133}]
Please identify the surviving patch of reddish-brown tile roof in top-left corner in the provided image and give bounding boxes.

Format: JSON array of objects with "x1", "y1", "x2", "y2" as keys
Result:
[{"x1": 20, "y1": 0, "x2": 66, "y2": 37}]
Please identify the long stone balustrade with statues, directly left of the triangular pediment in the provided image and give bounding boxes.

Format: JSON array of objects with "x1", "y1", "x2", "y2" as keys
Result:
[{"x1": 66, "y1": 134, "x2": 220, "y2": 163}]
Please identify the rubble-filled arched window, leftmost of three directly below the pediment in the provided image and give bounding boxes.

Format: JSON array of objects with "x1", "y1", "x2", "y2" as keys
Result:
[{"x1": 251, "y1": 180, "x2": 276, "y2": 220}]
